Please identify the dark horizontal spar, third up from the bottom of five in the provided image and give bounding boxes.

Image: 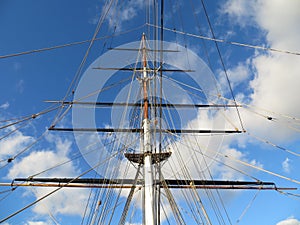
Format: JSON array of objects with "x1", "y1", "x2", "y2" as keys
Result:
[{"x1": 45, "y1": 100, "x2": 241, "y2": 108}]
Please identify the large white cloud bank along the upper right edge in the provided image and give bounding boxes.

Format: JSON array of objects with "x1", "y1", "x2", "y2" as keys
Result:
[{"x1": 224, "y1": 0, "x2": 300, "y2": 144}]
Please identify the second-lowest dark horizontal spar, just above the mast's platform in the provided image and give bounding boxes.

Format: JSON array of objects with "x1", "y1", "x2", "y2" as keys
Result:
[{"x1": 48, "y1": 127, "x2": 242, "y2": 134}]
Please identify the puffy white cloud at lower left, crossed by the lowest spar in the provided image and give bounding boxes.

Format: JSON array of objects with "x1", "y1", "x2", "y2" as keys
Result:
[{"x1": 7, "y1": 135, "x2": 89, "y2": 217}]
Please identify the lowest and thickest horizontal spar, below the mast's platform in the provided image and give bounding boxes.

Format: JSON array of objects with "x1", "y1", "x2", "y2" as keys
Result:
[{"x1": 8, "y1": 178, "x2": 297, "y2": 190}]
